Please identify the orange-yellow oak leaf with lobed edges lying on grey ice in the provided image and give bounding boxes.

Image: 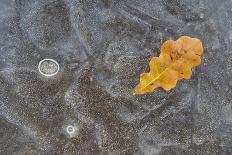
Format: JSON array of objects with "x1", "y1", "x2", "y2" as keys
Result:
[{"x1": 134, "y1": 36, "x2": 203, "y2": 95}]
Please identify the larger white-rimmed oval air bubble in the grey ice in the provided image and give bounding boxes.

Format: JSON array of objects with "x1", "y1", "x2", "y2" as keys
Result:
[{"x1": 38, "y1": 58, "x2": 60, "y2": 77}]
